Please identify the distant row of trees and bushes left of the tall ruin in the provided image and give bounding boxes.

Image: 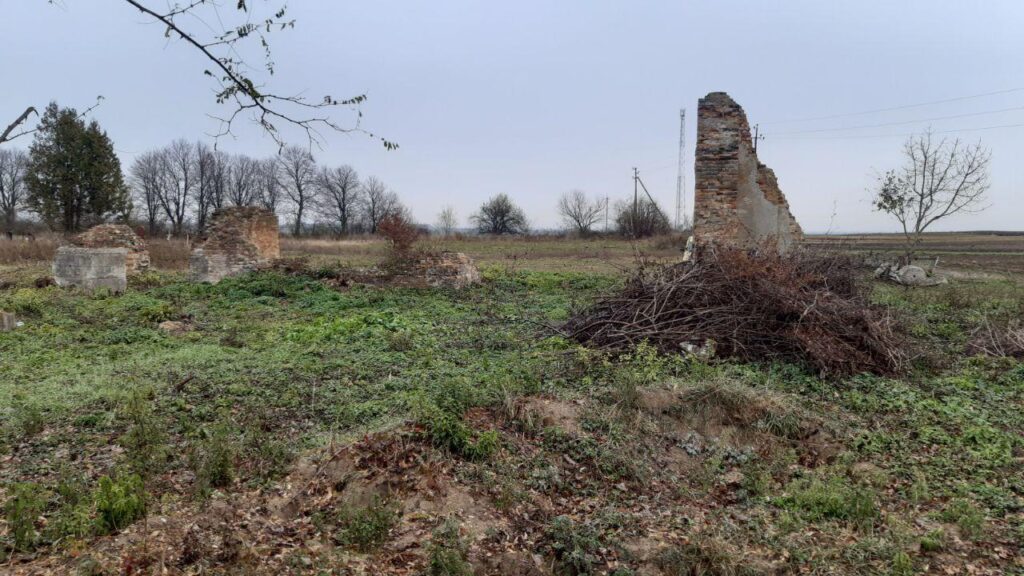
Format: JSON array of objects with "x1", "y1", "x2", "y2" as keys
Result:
[{"x1": 6, "y1": 104, "x2": 688, "y2": 238}]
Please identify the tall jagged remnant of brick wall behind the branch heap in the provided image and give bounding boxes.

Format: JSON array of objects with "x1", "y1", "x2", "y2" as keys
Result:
[{"x1": 693, "y1": 92, "x2": 803, "y2": 250}]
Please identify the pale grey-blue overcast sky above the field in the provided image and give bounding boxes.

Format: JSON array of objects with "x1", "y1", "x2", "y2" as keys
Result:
[{"x1": 0, "y1": 0, "x2": 1024, "y2": 232}]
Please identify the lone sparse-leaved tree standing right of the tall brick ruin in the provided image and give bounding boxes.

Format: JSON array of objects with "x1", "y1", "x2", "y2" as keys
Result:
[{"x1": 873, "y1": 130, "x2": 991, "y2": 259}]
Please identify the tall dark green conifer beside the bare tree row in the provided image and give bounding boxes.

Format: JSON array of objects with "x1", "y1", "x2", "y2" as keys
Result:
[{"x1": 25, "y1": 102, "x2": 131, "y2": 233}]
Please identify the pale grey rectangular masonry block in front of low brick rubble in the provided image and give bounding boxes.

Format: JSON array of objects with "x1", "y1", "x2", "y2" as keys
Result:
[{"x1": 53, "y1": 246, "x2": 128, "y2": 292}]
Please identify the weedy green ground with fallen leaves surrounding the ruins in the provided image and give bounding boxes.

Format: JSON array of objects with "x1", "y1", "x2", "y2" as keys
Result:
[{"x1": 0, "y1": 240, "x2": 1024, "y2": 575}]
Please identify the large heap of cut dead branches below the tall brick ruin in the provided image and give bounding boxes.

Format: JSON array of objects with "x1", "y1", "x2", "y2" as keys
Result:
[{"x1": 564, "y1": 242, "x2": 906, "y2": 375}]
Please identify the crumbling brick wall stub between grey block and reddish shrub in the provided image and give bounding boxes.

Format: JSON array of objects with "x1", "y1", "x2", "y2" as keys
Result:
[{"x1": 188, "y1": 206, "x2": 281, "y2": 283}]
